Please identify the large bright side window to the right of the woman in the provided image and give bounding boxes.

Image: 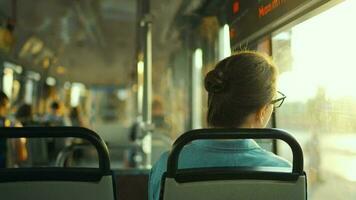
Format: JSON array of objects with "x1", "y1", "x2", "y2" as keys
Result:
[{"x1": 272, "y1": 0, "x2": 356, "y2": 200}]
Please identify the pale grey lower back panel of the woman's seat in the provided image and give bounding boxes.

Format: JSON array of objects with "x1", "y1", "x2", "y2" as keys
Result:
[{"x1": 163, "y1": 176, "x2": 306, "y2": 200}]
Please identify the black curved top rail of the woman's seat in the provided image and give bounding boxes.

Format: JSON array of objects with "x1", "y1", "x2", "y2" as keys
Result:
[{"x1": 167, "y1": 129, "x2": 304, "y2": 177}]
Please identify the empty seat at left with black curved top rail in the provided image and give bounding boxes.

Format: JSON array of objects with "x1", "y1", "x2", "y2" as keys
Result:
[{"x1": 0, "y1": 127, "x2": 116, "y2": 200}]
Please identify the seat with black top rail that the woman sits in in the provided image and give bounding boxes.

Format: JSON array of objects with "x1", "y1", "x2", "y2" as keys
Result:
[{"x1": 160, "y1": 129, "x2": 307, "y2": 200}]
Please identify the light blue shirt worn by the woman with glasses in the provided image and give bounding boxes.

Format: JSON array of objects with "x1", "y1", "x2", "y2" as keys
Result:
[{"x1": 148, "y1": 139, "x2": 291, "y2": 200}]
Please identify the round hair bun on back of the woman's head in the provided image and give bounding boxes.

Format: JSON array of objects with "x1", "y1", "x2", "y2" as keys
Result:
[{"x1": 204, "y1": 69, "x2": 228, "y2": 93}]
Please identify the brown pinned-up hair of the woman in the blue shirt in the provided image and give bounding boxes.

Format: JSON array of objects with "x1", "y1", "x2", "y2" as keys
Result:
[{"x1": 205, "y1": 51, "x2": 278, "y2": 127}]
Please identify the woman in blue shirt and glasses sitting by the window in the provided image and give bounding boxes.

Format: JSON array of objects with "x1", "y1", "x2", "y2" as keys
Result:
[{"x1": 149, "y1": 52, "x2": 290, "y2": 200}]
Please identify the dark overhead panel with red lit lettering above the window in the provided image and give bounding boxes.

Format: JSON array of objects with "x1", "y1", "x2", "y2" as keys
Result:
[{"x1": 225, "y1": 0, "x2": 336, "y2": 48}]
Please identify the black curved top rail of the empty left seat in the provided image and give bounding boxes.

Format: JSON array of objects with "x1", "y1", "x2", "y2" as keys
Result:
[{"x1": 0, "y1": 127, "x2": 110, "y2": 172}]
